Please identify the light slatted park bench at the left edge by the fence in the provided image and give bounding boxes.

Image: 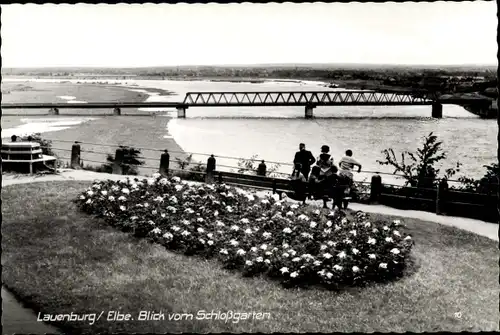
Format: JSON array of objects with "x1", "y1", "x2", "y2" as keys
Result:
[{"x1": 1, "y1": 142, "x2": 57, "y2": 174}]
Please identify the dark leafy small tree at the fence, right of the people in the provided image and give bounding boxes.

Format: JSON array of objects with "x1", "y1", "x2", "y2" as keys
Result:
[{"x1": 377, "y1": 133, "x2": 461, "y2": 188}]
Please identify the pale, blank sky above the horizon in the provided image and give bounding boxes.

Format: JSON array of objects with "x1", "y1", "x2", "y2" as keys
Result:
[{"x1": 1, "y1": 1, "x2": 497, "y2": 67}]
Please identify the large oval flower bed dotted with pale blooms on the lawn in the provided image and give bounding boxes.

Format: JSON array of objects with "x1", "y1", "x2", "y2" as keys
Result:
[{"x1": 76, "y1": 175, "x2": 413, "y2": 287}]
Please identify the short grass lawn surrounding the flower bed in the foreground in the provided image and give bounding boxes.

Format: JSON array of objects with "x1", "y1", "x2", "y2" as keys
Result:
[{"x1": 2, "y1": 182, "x2": 499, "y2": 333}]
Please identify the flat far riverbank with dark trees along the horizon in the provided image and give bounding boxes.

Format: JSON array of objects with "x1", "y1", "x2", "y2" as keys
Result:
[{"x1": 2, "y1": 65, "x2": 497, "y2": 98}]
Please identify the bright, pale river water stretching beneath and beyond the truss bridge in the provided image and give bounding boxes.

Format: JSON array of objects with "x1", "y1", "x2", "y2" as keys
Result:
[{"x1": 2, "y1": 80, "x2": 498, "y2": 186}]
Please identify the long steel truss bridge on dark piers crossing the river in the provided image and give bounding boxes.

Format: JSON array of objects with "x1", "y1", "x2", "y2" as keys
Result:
[{"x1": 1, "y1": 91, "x2": 491, "y2": 119}]
